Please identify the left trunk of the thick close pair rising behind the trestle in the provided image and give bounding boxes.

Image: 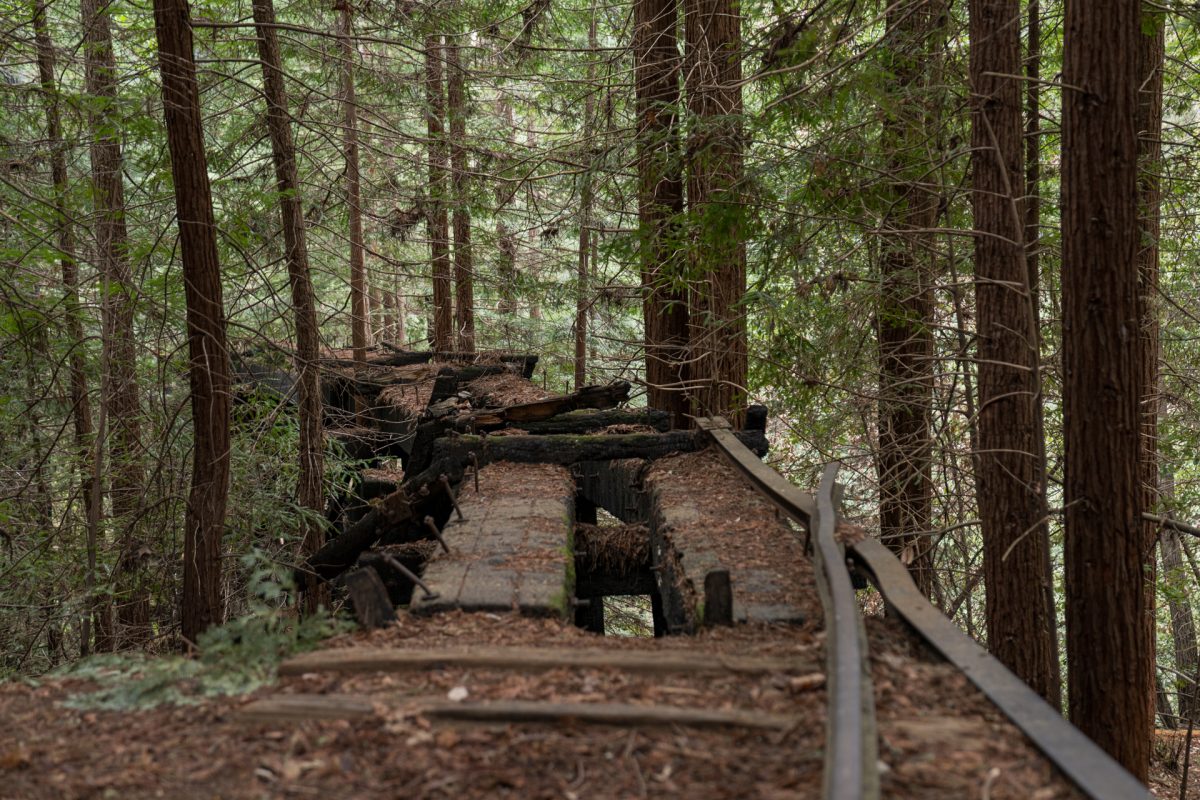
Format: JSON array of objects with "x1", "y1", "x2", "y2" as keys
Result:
[{"x1": 634, "y1": 0, "x2": 690, "y2": 427}]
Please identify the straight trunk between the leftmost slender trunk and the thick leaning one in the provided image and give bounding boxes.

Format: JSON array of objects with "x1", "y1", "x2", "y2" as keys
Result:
[{"x1": 80, "y1": 0, "x2": 150, "y2": 649}]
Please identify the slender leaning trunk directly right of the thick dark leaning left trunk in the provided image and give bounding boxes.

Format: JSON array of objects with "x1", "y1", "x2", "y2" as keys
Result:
[{"x1": 253, "y1": 0, "x2": 326, "y2": 610}]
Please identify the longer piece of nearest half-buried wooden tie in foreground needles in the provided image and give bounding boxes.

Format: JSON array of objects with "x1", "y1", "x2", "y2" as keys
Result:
[{"x1": 421, "y1": 700, "x2": 800, "y2": 730}]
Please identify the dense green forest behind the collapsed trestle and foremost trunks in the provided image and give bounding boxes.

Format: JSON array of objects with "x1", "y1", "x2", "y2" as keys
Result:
[{"x1": 0, "y1": 0, "x2": 1200, "y2": 777}]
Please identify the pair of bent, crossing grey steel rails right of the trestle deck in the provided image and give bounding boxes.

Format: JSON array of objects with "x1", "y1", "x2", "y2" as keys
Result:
[{"x1": 697, "y1": 417, "x2": 1150, "y2": 800}]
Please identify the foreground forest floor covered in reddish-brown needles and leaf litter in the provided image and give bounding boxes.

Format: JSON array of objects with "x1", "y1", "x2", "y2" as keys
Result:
[{"x1": 0, "y1": 613, "x2": 1099, "y2": 800}]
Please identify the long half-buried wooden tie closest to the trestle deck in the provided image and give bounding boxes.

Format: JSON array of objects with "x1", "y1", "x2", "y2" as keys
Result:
[{"x1": 278, "y1": 646, "x2": 820, "y2": 675}]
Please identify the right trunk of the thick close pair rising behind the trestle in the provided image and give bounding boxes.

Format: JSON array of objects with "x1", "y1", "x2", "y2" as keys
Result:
[{"x1": 681, "y1": 0, "x2": 748, "y2": 420}]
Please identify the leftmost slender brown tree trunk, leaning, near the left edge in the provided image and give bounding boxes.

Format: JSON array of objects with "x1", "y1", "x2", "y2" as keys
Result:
[{"x1": 34, "y1": 0, "x2": 98, "y2": 656}]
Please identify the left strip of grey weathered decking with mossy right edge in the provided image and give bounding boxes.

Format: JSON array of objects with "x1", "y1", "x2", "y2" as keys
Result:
[{"x1": 412, "y1": 464, "x2": 575, "y2": 616}]
